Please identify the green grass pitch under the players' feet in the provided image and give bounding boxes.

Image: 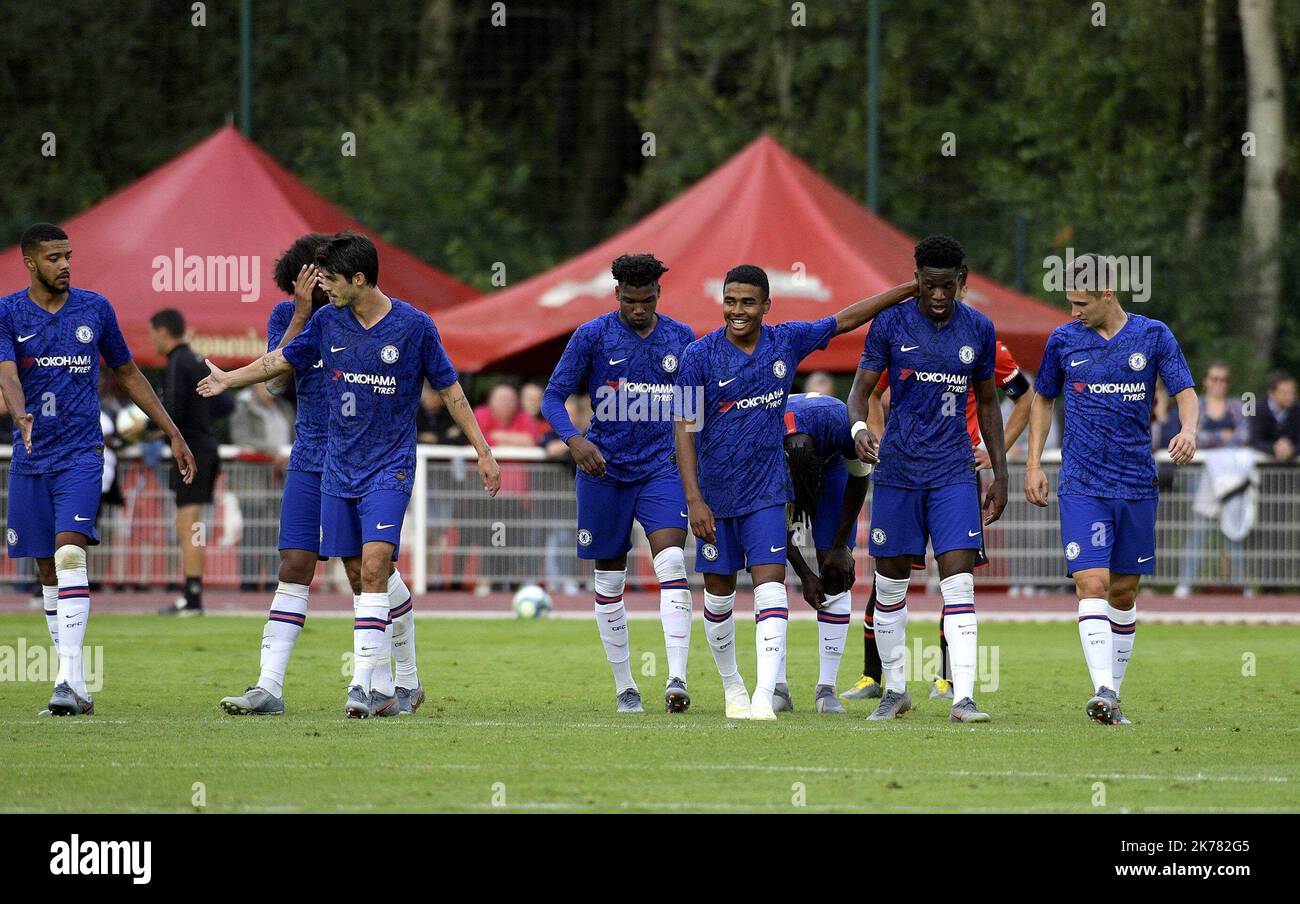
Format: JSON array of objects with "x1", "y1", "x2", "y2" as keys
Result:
[{"x1": 0, "y1": 613, "x2": 1300, "y2": 813}]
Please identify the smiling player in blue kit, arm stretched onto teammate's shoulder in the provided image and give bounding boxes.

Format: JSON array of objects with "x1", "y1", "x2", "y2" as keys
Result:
[{"x1": 673, "y1": 264, "x2": 914, "y2": 719}]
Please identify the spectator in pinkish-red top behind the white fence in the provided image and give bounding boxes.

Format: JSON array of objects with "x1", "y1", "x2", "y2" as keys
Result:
[{"x1": 475, "y1": 382, "x2": 542, "y2": 593}]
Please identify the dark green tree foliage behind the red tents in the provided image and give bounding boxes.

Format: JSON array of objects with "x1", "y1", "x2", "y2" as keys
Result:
[{"x1": 0, "y1": 0, "x2": 1300, "y2": 388}]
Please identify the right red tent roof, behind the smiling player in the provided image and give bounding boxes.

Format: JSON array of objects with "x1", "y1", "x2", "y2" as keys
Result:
[{"x1": 438, "y1": 135, "x2": 1066, "y2": 372}]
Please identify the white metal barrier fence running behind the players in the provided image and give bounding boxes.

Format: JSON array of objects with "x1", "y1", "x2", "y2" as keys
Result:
[{"x1": 0, "y1": 446, "x2": 1300, "y2": 592}]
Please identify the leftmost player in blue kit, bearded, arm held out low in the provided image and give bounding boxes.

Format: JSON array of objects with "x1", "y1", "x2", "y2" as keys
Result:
[{"x1": 0, "y1": 222, "x2": 195, "y2": 715}]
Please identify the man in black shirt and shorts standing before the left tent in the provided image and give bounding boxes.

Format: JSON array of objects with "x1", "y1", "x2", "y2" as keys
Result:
[{"x1": 150, "y1": 308, "x2": 229, "y2": 615}]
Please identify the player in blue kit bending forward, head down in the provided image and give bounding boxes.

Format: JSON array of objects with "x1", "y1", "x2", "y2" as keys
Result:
[{"x1": 774, "y1": 393, "x2": 871, "y2": 713}]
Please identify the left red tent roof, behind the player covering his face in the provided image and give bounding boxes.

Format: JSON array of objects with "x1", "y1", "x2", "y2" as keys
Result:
[{"x1": 0, "y1": 126, "x2": 480, "y2": 364}]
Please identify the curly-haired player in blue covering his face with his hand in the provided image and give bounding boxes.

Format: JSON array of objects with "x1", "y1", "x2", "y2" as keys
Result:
[{"x1": 221, "y1": 233, "x2": 424, "y2": 715}]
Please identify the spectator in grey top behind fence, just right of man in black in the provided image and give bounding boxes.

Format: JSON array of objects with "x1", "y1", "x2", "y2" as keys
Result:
[{"x1": 230, "y1": 382, "x2": 294, "y2": 591}]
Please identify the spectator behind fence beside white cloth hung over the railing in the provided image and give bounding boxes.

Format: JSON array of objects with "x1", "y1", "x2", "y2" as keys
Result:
[{"x1": 1162, "y1": 362, "x2": 1251, "y2": 598}]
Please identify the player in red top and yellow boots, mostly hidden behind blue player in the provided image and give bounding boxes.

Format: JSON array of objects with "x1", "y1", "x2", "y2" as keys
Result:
[{"x1": 842, "y1": 341, "x2": 1034, "y2": 700}]
